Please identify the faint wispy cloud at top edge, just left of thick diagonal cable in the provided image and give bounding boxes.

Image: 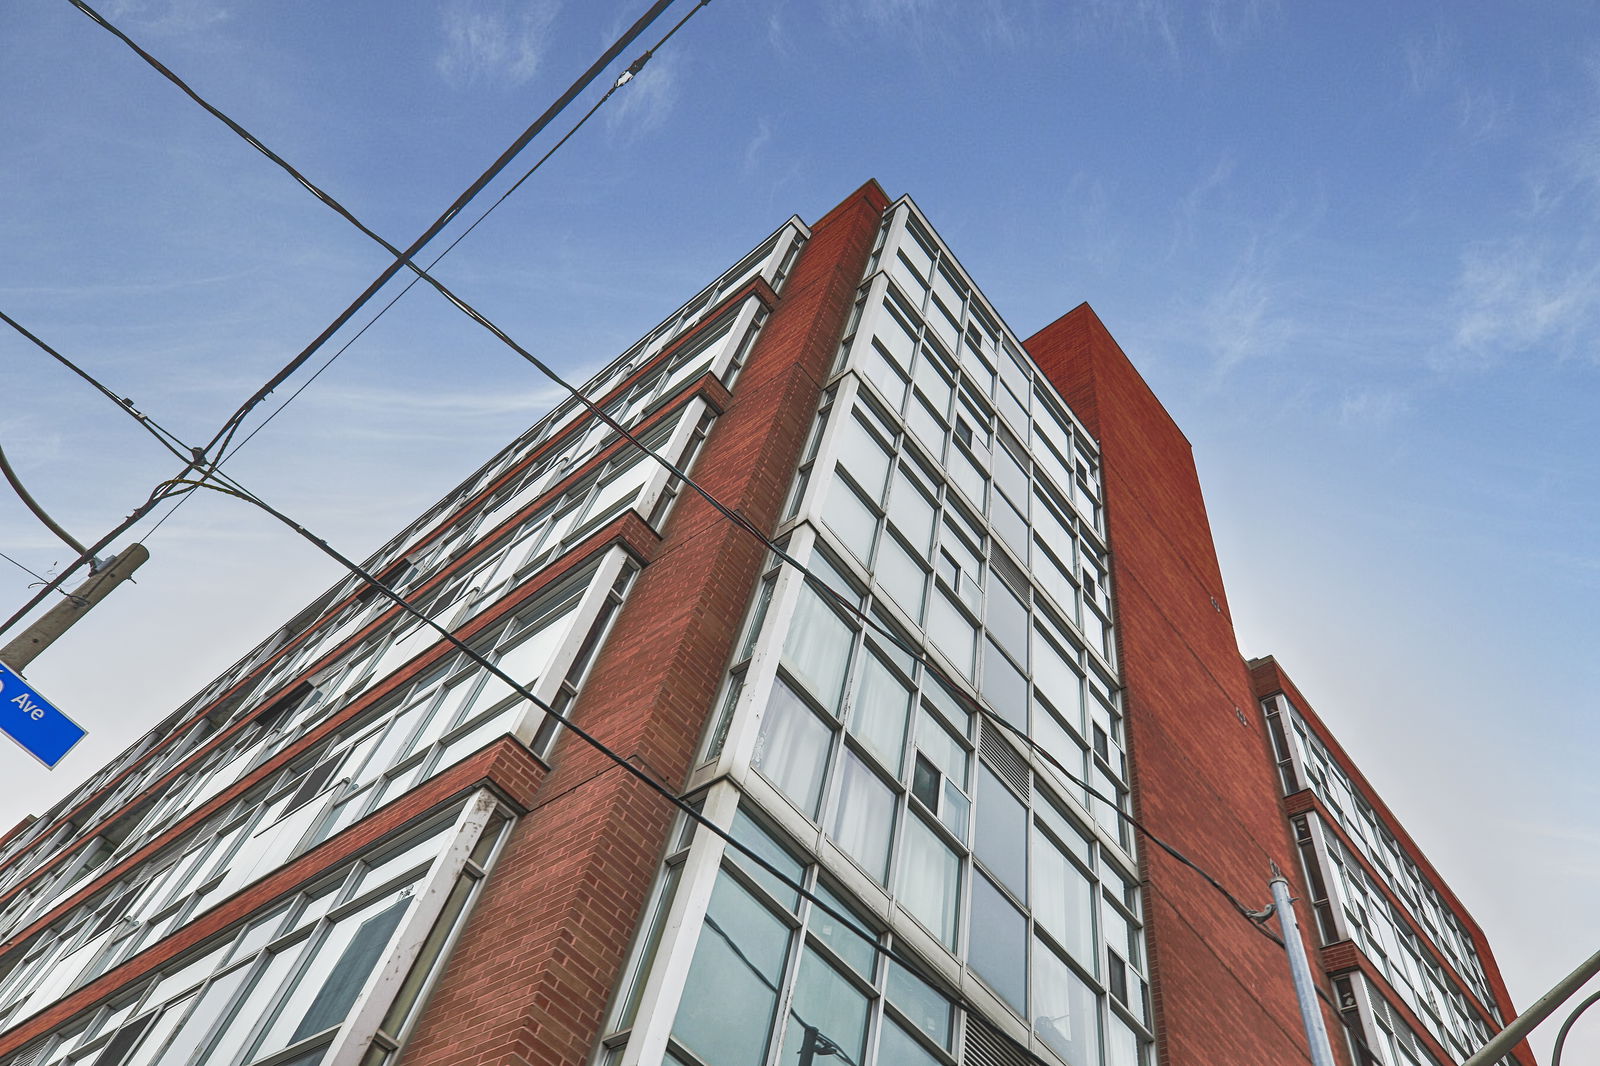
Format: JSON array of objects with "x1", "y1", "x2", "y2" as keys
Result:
[{"x1": 434, "y1": 0, "x2": 557, "y2": 86}]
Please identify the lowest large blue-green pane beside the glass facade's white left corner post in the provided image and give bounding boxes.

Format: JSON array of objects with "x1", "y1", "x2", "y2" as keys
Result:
[{"x1": 672, "y1": 874, "x2": 789, "y2": 1066}]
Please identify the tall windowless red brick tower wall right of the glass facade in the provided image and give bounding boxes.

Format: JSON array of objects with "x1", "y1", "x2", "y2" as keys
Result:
[{"x1": 1027, "y1": 304, "x2": 1344, "y2": 1066}]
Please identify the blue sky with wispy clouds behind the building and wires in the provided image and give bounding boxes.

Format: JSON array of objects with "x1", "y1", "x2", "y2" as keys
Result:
[{"x1": 0, "y1": 0, "x2": 1600, "y2": 1061}]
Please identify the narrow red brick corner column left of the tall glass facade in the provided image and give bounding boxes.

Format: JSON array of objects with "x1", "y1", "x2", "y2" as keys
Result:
[{"x1": 403, "y1": 182, "x2": 888, "y2": 1066}]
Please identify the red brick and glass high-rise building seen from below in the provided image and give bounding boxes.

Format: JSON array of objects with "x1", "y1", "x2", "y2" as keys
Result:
[{"x1": 0, "y1": 184, "x2": 1533, "y2": 1066}]
